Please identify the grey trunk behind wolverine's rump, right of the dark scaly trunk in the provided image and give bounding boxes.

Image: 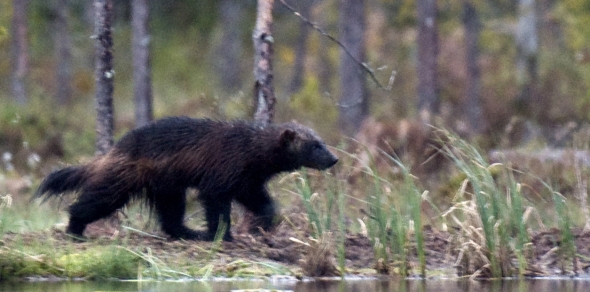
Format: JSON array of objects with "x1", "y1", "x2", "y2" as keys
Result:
[{"x1": 131, "y1": 0, "x2": 153, "y2": 128}]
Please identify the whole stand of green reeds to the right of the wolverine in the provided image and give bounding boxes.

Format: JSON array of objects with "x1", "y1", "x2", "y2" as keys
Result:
[{"x1": 296, "y1": 131, "x2": 588, "y2": 278}]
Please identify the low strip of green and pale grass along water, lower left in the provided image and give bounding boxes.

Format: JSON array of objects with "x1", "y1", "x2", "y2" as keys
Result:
[{"x1": 0, "y1": 230, "x2": 300, "y2": 280}]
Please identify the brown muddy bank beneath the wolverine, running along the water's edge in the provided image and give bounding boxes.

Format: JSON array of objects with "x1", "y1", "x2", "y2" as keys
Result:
[{"x1": 1, "y1": 210, "x2": 590, "y2": 277}]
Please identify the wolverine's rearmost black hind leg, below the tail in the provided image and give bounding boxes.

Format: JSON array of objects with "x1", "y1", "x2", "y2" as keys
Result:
[{"x1": 67, "y1": 190, "x2": 129, "y2": 238}]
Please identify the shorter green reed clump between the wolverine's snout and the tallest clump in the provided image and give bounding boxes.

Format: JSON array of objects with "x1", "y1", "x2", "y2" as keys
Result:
[{"x1": 352, "y1": 145, "x2": 426, "y2": 276}]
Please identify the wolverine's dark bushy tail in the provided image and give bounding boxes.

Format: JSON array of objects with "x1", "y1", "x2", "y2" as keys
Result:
[{"x1": 35, "y1": 166, "x2": 86, "y2": 199}]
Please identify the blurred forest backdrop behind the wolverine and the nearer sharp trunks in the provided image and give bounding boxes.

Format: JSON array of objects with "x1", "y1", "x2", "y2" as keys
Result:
[{"x1": 0, "y1": 0, "x2": 590, "y2": 217}]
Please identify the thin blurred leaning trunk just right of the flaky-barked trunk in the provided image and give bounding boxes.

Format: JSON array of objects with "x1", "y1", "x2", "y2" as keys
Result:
[{"x1": 289, "y1": 0, "x2": 313, "y2": 94}]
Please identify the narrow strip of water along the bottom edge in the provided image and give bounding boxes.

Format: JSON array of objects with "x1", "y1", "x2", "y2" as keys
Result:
[{"x1": 0, "y1": 279, "x2": 590, "y2": 292}]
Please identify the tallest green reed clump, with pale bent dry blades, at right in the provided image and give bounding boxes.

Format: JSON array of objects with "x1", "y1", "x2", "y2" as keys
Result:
[{"x1": 439, "y1": 130, "x2": 529, "y2": 278}]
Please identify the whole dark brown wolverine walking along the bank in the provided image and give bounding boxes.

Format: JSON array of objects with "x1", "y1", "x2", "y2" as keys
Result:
[{"x1": 37, "y1": 117, "x2": 338, "y2": 240}]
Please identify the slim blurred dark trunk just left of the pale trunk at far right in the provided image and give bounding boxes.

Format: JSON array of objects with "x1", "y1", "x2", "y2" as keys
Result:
[{"x1": 463, "y1": 0, "x2": 484, "y2": 135}]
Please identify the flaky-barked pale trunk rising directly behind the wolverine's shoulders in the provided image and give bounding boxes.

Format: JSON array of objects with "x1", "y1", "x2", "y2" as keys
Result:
[{"x1": 252, "y1": 0, "x2": 276, "y2": 124}]
